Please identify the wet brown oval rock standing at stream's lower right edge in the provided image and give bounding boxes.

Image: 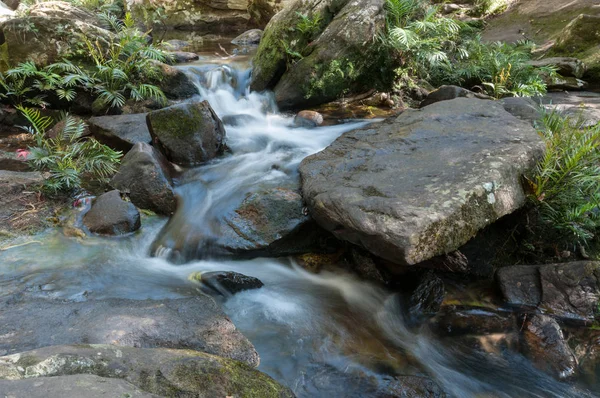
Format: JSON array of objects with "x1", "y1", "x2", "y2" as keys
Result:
[{"x1": 521, "y1": 315, "x2": 577, "y2": 379}]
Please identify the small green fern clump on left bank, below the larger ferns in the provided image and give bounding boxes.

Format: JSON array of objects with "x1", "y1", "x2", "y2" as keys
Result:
[{"x1": 17, "y1": 106, "x2": 121, "y2": 192}]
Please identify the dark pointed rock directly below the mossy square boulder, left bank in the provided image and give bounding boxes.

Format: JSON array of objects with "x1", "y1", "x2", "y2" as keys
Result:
[{"x1": 110, "y1": 142, "x2": 176, "y2": 215}]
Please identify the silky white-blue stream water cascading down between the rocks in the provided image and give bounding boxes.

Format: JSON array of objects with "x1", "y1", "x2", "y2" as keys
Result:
[{"x1": 0, "y1": 45, "x2": 591, "y2": 397}]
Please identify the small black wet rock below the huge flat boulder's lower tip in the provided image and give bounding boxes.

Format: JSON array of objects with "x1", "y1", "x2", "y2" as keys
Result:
[{"x1": 408, "y1": 271, "x2": 445, "y2": 318}]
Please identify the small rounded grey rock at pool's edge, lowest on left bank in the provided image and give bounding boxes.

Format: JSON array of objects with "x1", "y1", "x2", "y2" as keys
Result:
[{"x1": 83, "y1": 190, "x2": 142, "y2": 235}]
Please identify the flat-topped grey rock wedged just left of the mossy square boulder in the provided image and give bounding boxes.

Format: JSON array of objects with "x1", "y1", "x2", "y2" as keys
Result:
[{"x1": 88, "y1": 113, "x2": 152, "y2": 152}]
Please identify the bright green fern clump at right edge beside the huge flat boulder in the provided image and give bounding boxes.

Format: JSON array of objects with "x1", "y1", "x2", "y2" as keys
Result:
[{"x1": 528, "y1": 111, "x2": 600, "y2": 243}]
